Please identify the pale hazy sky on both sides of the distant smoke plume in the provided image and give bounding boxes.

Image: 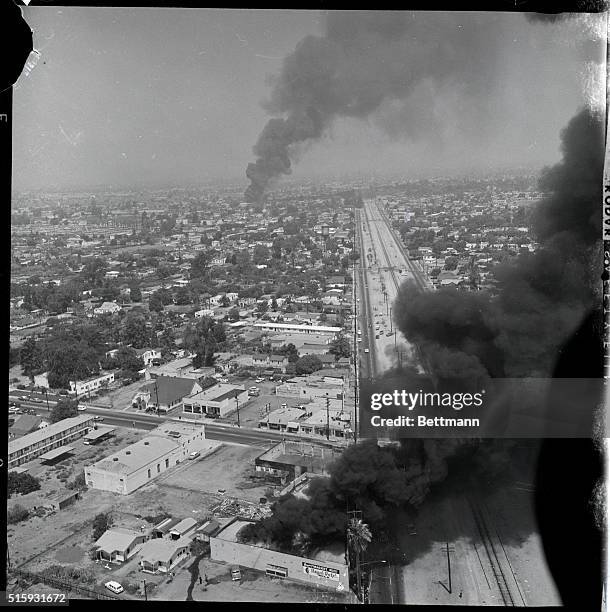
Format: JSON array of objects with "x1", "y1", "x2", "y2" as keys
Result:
[{"x1": 13, "y1": 7, "x2": 604, "y2": 190}]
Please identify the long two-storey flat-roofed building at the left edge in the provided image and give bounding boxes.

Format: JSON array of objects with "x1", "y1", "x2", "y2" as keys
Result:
[{"x1": 8, "y1": 415, "x2": 95, "y2": 469}]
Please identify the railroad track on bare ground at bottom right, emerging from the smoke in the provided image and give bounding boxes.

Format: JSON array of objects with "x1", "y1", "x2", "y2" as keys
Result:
[{"x1": 468, "y1": 498, "x2": 527, "y2": 607}]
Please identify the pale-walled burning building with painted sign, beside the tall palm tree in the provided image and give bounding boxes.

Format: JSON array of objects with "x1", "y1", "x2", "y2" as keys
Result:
[{"x1": 210, "y1": 519, "x2": 349, "y2": 593}]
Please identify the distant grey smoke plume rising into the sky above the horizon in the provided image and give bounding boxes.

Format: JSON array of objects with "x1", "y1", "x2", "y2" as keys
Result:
[{"x1": 246, "y1": 12, "x2": 501, "y2": 201}]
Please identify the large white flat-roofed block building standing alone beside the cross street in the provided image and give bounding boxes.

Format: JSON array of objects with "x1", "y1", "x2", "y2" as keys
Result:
[{"x1": 85, "y1": 421, "x2": 211, "y2": 495}]
